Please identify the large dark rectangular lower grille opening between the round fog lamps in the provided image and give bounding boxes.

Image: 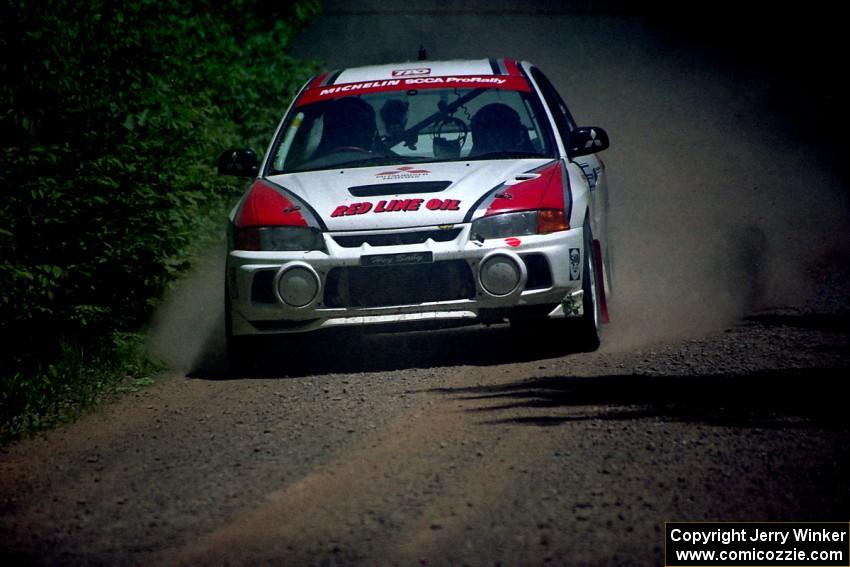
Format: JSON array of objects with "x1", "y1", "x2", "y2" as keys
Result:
[{"x1": 324, "y1": 260, "x2": 475, "y2": 307}]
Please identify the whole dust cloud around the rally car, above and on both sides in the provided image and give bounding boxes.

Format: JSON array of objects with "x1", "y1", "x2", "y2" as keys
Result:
[{"x1": 149, "y1": 5, "x2": 850, "y2": 368}]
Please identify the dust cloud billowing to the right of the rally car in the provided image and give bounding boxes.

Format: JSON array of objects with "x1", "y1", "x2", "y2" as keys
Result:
[{"x1": 550, "y1": 20, "x2": 850, "y2": 348}]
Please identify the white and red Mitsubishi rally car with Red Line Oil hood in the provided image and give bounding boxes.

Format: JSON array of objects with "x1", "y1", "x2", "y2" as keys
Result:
[{"x1": 218, "y1": 59, "x2": 611, "y2": 364}]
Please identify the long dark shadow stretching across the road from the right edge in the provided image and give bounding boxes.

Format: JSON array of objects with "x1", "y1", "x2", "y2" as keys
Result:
[{"x1": 429, "y1": 368, "x2": 850, "y2": 428}]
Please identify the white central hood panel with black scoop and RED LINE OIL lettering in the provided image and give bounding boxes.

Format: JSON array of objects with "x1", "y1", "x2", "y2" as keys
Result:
[{"x1": 267, "y1": 159, "x2": 553, "y2": 232}]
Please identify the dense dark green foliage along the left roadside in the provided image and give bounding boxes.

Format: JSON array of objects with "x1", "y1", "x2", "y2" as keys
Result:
[{"x1": 0, "y1": 0, "x2": 318, "y2": 440}]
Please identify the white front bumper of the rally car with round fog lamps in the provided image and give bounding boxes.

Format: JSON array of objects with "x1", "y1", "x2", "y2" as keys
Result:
[{"x1": 227, "y1": 224, "x2": 585, "y2": 335}]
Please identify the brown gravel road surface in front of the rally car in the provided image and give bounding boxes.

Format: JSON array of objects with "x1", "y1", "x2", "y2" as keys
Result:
[{"x1": 0, "y1": 302, "x2": 850, "y2": 565}]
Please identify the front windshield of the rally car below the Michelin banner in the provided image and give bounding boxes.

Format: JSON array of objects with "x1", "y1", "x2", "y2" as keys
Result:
[{"x1": 269, "y1": 88, "x2": 555, "y2": 174}]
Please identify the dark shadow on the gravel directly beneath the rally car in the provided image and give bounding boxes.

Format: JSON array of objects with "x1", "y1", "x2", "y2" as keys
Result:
[{"x1": 189, "y1": 325, "x2": 578, "y2": 380}]
